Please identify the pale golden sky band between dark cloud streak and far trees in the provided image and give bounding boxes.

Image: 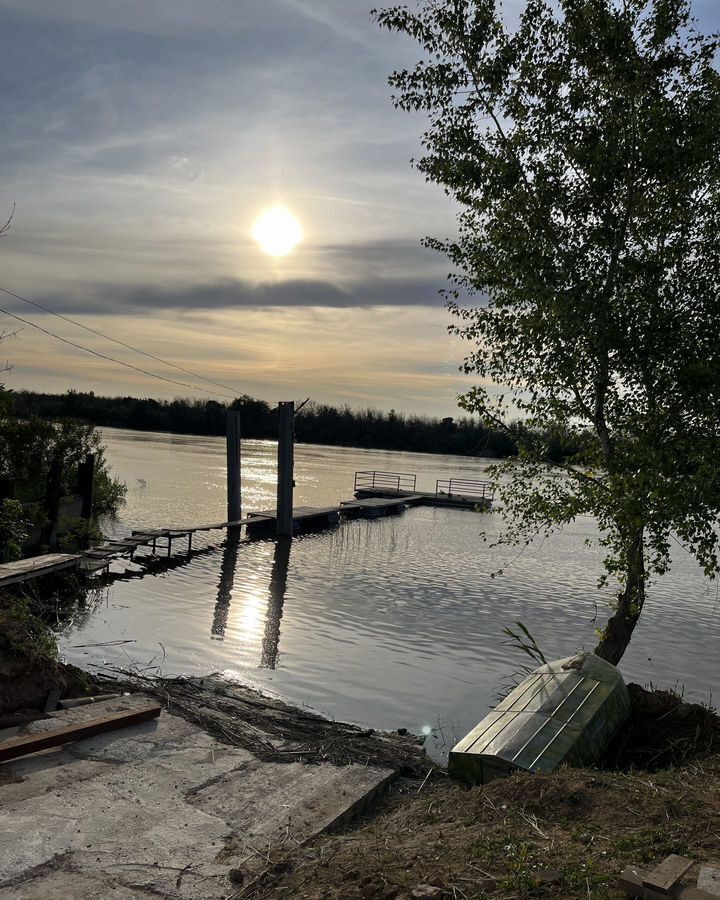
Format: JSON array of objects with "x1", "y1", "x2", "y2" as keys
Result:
[{"x1": 5, "y1": 306, "x2": 473, "y2": 415}]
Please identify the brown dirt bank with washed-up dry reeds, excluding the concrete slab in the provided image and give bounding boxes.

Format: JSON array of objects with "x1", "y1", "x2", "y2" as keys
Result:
[{"x1": 2, "y1": 624, "x2": 720, "y2": 900}]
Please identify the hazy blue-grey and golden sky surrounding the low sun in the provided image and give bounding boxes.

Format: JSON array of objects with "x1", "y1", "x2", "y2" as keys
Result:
[{"x1": 0, "y1": 0, "x2": 720, "y2": 416}]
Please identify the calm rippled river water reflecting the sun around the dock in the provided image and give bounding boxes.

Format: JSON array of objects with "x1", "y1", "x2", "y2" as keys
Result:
[{"x1": 61, "y1": 429, "x2": 720, "y2": 750}]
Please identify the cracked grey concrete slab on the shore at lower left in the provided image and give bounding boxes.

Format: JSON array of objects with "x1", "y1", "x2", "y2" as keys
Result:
[{"x1": 0, "y1": 695, "x2": 394, "y2": 900}]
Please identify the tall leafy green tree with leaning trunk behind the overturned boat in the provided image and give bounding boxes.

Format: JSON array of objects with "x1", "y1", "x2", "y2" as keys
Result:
[{"x1": 374, "y1": 0, "x2": 720, "y2": 663}]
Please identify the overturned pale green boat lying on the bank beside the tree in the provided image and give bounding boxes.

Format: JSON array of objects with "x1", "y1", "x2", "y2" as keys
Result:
[{"x1": 448, "y1": 653, "x2": 630, "y2": 784}]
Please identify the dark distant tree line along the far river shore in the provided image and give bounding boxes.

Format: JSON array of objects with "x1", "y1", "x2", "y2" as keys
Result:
[{"x1": 7, "y1": 391, "x2": 574, "y2": 459}]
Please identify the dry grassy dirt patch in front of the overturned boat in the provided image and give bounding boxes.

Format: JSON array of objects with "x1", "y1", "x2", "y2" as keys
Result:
[{"x1": 242, "y1": 756, "x2": 720, "y2": 900}]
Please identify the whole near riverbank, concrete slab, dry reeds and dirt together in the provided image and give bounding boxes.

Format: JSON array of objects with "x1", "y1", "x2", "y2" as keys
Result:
[{"x1": 0, "y1": 652, "x2": 720, "y2": 900}]
